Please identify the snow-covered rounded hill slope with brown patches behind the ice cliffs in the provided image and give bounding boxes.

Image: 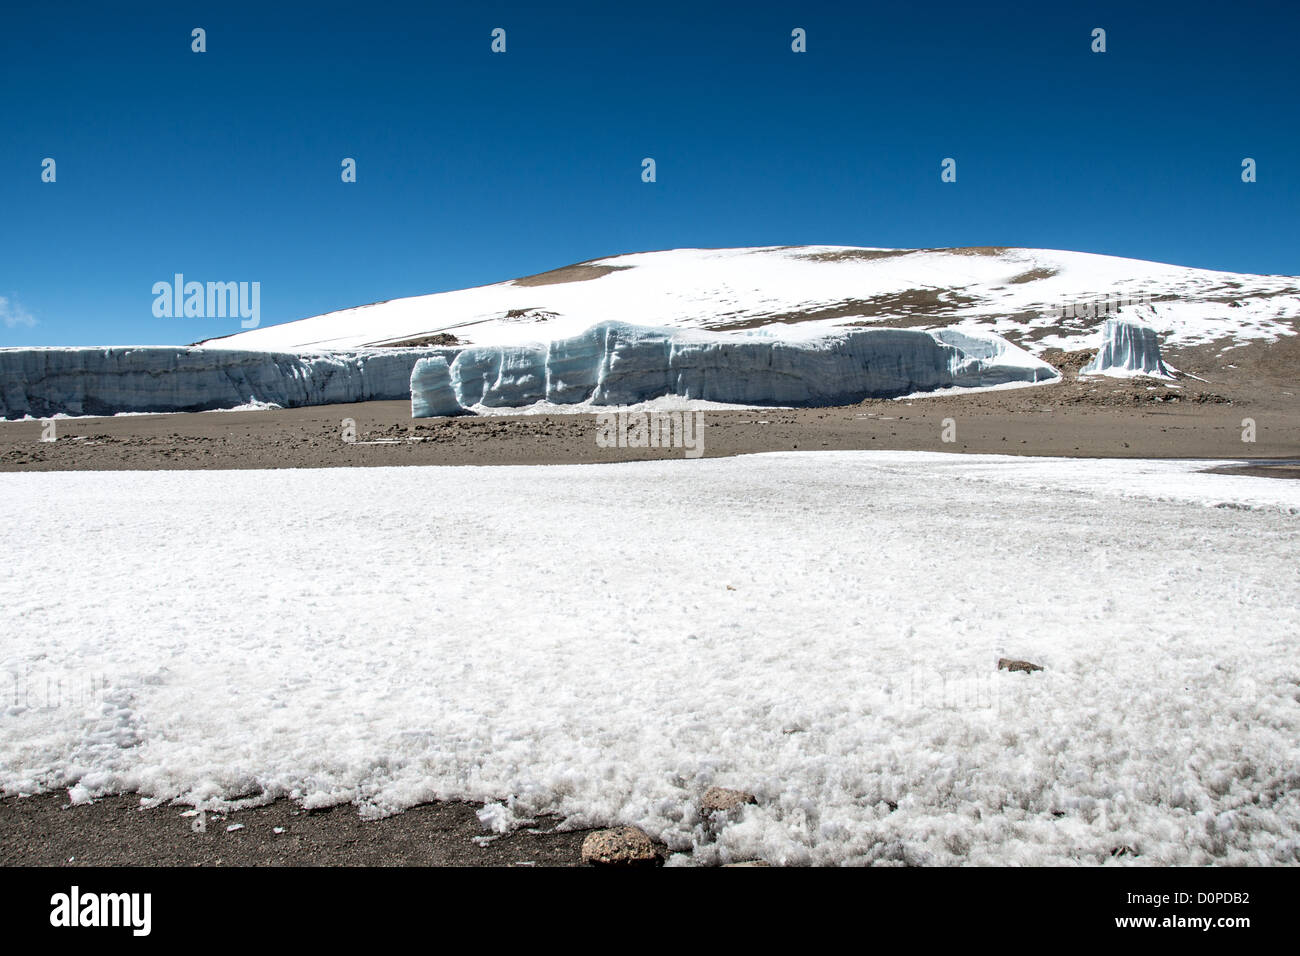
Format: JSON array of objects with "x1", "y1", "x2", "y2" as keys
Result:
[{"x1": 202, "y1": 246, "x2": 1300, "y2": 351}]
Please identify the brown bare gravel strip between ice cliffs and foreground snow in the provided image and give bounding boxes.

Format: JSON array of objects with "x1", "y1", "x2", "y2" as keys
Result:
[{"x1": 0, "y1": 363, "x2": 1300, "y2": 472}]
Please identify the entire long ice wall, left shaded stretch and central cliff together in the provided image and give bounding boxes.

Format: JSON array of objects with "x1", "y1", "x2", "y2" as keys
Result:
[{"x1": 0, "y1": 321, "x2": 1057, "y2": 419}]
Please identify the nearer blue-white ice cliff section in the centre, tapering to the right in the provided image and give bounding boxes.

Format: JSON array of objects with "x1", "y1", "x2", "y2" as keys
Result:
[{"x1": 411, "y1": 323, "x2": 1057, "y2": 418}]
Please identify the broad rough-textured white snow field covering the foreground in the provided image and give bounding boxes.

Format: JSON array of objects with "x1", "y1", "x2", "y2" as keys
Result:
[{"x1": 0, "y1": 453, "x2": 1300, "y2": 864}]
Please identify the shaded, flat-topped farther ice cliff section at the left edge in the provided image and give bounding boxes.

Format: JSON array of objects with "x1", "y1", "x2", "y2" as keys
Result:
[{"x1": 0, "y1": 347, "x2": 455, "y2": 419}]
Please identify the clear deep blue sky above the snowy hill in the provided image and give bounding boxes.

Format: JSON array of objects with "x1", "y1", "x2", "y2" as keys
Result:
[{"x1": 0, "y1": 0, "x2": 1300, "y2": 346}]
